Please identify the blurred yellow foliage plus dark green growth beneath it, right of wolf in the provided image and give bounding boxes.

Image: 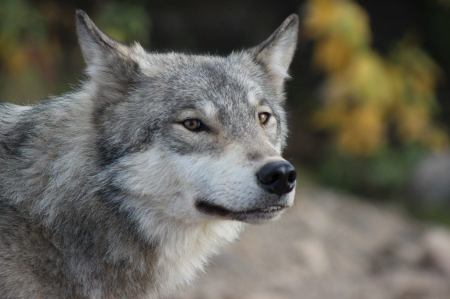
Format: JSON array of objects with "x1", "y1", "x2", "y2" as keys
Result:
[{"x1": 304, "y1": 0, "x2": 449, "y2": 204}]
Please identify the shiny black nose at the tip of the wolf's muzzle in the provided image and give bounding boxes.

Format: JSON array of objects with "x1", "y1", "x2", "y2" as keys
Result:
[{"x1": 256, "y1": 161, "x2": 297, "y2": 195}]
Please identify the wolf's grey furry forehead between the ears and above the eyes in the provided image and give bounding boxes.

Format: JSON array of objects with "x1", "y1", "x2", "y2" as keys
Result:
[{"x1": 121, "y1": 53, "x2": 282, "y2": 120}]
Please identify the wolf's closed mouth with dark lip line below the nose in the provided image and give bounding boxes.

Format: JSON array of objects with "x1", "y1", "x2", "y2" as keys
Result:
[{"x1": 196, "y1": 200, "x2": 288, "y2": 221}]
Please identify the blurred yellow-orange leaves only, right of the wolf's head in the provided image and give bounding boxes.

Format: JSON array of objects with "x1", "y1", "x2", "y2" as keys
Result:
[{"x1": 305, "y1": 0, "x2": 448, "y2": 156}]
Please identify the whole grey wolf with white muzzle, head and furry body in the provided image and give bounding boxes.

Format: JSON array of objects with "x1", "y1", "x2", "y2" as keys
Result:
[{"x1": 0, "y1": 11, "x2": 298, "y2": 299}]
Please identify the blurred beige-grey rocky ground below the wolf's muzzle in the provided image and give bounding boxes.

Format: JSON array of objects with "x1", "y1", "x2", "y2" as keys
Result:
[{"x1": 173, "y1": 188, "x2": 450, "y2": 299}]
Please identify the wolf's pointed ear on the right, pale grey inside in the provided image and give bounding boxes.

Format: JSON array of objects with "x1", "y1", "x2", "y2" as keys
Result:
[{"x1": 249, "y1": 14, "x2": 298, "y2": 92}]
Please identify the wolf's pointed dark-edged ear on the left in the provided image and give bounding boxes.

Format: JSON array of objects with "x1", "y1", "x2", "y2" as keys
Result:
[{"x1": 76, "y1": 10, "x2": 137, "y2": 84}]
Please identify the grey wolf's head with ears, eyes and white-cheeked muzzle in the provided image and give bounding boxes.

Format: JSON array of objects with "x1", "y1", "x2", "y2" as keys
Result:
[{"x1": 77, "y1": 11, "x2": 298, "y2": 225}]
